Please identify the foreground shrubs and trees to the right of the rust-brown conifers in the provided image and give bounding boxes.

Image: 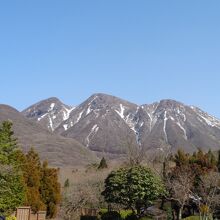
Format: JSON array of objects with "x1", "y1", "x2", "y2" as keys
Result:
[{"x1": 62, "y1": 145, "x2": 220, "y2": 219}]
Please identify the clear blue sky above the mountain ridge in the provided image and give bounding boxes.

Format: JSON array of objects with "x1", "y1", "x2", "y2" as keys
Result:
[{"x1": 0, "y1": 0, "x2": 220, "y2": 118}]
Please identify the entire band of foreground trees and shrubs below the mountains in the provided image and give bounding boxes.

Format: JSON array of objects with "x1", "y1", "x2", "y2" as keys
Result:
[{"x1": 0, "y1": 121, "x2": 220, "y2": 220}]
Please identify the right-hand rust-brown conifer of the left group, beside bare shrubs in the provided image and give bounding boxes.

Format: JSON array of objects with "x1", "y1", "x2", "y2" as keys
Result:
[{"x1": 40, "y1": 161, "x2": 61, "y2": 218}]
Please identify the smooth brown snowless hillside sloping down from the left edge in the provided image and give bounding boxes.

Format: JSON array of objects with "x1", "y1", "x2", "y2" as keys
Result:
[{"x1": 0, "y1": 105, "x2": 96, "y2": 166}]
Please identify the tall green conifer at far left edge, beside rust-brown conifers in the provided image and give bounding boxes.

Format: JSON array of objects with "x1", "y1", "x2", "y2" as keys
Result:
[{"x1": 0, "y1": 121, "x2": 25, "y2": 215}]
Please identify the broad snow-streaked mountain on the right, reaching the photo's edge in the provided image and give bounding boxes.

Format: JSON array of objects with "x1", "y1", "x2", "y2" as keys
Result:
[{"x1": 139, "y1": 100, "x2": 220, "y2": 152}]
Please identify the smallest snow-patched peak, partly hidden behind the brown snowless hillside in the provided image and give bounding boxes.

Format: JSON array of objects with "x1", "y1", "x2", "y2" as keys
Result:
[{"x1": 22, "y1": 97, "x2": 74, "y2": 131}]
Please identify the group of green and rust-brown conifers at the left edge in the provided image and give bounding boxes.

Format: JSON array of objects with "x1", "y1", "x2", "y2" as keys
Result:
[{"x1": 0, "y1": 121, "x2": 61, "y2": 218}]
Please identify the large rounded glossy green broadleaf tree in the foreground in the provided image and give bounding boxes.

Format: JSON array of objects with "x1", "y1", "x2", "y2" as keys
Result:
[{"x1": 102, "y1": 166, "x2": 166, "y2": 213}]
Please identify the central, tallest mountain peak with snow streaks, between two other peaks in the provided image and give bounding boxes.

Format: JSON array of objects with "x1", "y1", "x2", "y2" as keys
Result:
[{"x1": 55, "y1": 94, "x2": 137, "y2": 154}]
